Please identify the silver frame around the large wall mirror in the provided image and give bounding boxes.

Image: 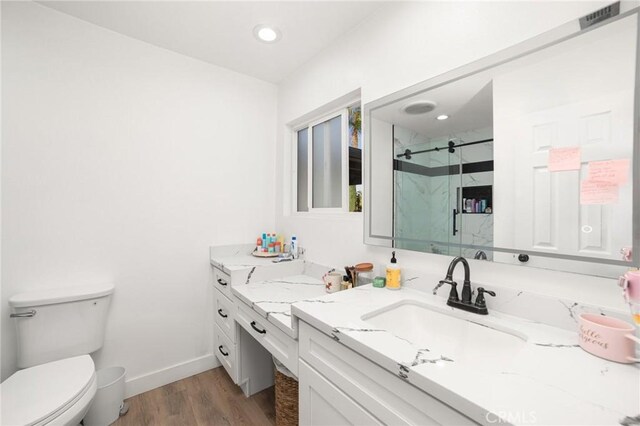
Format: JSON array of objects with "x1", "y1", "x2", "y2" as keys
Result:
[{"x1": 363, "y1": 2, "x2": 640, "y2": 277}]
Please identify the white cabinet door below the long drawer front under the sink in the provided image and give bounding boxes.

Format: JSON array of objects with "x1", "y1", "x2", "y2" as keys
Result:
[{"x1": 298, "y1": 360, "x2": 382, "y2": 426}]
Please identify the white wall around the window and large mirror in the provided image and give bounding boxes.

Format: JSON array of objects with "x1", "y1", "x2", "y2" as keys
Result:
[{"x1": 276, "y1": 1, "x2": 623, "y2": 309}]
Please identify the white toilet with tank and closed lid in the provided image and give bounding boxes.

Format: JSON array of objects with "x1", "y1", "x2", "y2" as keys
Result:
[{"x1": 0, "y1": 284, "x2": 113, "y2": 426}]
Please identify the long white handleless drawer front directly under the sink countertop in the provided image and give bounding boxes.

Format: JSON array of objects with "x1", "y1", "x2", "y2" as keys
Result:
[{"x1": 298, "y1": 321, "x2": 476, "y2": 425}]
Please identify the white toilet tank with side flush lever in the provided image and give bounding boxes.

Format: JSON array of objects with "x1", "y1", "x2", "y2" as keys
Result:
[{"x1": 9, "y1": 284, "x2": 113, "y2": 368}]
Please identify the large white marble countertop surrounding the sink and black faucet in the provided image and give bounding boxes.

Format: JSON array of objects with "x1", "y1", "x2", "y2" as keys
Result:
[{"x1": 292, "y1": 283, "x2": 640, "y2": 425}]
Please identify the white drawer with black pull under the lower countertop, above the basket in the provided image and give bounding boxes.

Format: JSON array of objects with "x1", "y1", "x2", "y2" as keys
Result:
[{"x1": 236, "y1": 300, "x2": 298, "y2": 376}]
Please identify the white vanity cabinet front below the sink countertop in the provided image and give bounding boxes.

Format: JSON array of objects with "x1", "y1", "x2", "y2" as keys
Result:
[{"x1": 298, "y1": 320, "x2": 476, "y2": 425}]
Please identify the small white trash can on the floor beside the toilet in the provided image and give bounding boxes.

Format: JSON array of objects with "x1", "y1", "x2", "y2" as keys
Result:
[{"x1": 83, "y1": 367, "x2": 125, "y2": 426}]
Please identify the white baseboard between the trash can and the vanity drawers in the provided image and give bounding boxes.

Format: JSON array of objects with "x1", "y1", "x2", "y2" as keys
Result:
[{"x1": 125, "y1": 354, "x2": 220, "y2": 398}]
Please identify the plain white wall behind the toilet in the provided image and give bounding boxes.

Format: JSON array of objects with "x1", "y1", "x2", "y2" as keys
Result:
[{"x1": 2, "y1": 2, "x2": 277, "y2": 393}]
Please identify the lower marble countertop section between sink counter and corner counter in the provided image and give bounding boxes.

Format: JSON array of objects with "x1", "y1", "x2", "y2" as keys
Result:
[{"x1": 231, "y1": 275, "x2": 327, "y2": 339}]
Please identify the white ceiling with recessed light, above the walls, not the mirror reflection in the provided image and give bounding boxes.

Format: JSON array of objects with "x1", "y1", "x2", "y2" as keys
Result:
[{"x1": 39, "y1": 0, "x2": 387, "y2": 83}]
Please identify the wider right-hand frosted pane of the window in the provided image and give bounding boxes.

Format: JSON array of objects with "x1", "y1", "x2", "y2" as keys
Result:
[{"x1": 312, "y1": 116, "x2": 342, "y2": 208}]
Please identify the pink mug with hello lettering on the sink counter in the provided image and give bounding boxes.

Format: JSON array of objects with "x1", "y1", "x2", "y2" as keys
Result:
[{"x1": 579, "y1": 314, "x2": 640, "y2": 364}]
